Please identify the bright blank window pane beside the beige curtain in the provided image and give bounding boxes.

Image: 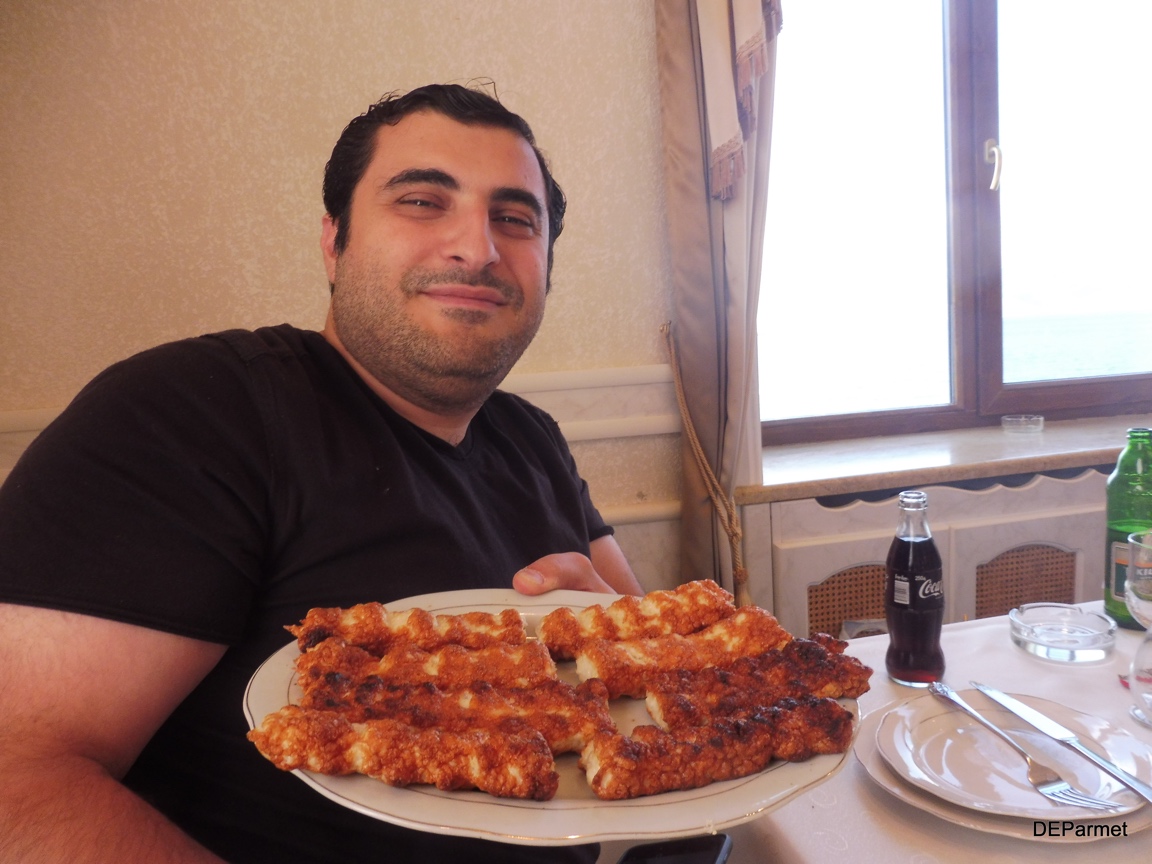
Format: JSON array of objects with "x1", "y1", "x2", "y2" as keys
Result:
[{"x1": 757, "y1": 0, "x2": 952, "y2": 420}]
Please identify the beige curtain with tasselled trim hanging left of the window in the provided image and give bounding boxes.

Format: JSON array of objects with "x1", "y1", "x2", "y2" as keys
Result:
[{"x1": 657, "y1": 0, "x2": 781, "y2": 601}]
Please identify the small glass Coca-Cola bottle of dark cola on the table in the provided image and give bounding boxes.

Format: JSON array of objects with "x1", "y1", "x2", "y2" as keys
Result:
[{"x1": 884, "y1": 492, "x2": 943, "y2": 687}]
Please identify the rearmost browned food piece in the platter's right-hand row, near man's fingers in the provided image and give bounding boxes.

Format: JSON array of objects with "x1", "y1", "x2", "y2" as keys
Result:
[{"x1": 536, "y1": 579, "x2": 736, "y2": 660}]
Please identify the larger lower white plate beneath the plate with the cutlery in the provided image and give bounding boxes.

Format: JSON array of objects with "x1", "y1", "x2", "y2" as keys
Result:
[{"x1": 854, "y1": 710, "x2": 1152, "y2": 843}]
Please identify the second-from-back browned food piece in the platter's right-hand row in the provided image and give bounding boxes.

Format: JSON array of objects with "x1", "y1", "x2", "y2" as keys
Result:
[{"x1": 576, "y1": 606, "x2": 791, "y2": 699}]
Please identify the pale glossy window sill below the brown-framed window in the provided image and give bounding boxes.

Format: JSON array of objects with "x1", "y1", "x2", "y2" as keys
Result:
[{"x1": 736, "y1": 415, "x2": 1152, "y2": 505}]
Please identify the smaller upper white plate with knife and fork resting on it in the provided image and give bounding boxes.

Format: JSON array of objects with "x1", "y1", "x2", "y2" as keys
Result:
[{"x1": 876, "y1": 690, "x2": 1152, "y2": 820}]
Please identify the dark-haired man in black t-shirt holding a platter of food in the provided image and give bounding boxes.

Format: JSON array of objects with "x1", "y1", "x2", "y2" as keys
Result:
[{"x1": 0, "y1": 86, "x2": 641, "y2": 864}]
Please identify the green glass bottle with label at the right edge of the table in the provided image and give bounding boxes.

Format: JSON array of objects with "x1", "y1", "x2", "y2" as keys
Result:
[{"x1": 1104, "y1": 427, "x2": 1152, "y2": 630}]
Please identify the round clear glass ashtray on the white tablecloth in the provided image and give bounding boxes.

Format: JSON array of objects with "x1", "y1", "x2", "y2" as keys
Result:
[{"x1": 1008, "y1": 602, "x2": 1116, "y2": 664}]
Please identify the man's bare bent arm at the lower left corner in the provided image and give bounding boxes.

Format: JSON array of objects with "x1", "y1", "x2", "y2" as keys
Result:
[{"x1": 0, "y1": 604, "x2": 231, "y2": 864}]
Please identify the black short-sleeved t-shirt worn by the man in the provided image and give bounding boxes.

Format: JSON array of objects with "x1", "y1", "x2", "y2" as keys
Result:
[{"x1": 0, "y1": 325, "x2": 611, "y2": 864}]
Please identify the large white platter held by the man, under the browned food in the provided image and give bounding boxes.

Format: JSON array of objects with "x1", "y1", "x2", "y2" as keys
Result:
[{"x1": 244, "y1": 589, "x2": 858, "y2": 846}]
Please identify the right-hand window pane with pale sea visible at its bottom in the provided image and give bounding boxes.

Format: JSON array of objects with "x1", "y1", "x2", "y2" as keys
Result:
[{"x1": 999, "y1": 0, "x2": 1152, "y2": 382}]
